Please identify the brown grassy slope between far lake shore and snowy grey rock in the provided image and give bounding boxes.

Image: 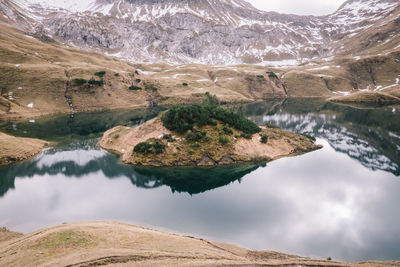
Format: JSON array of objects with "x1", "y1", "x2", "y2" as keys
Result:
[{"x1": 0, "y1": 22, "x2": 400, "y2": 119}]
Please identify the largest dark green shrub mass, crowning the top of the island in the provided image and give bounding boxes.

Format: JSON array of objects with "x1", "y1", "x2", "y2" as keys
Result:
[{"x1": 161, "y1": 104, "x2": 261, "y2": 134}]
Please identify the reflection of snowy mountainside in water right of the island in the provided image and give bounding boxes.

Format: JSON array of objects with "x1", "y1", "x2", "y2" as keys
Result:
[{"x1": 243, "y1": 99, "x2": 400, "y2": 176}]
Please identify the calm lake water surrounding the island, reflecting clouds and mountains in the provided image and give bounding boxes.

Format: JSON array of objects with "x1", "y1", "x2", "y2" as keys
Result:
[{"x1": 0, "y1": 99, "x2": 400, "y2": 261}]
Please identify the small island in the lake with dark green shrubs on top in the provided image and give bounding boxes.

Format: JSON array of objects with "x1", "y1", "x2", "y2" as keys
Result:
[{"x1": 100, "y1": 104, "x2": 321, "y2": 166}]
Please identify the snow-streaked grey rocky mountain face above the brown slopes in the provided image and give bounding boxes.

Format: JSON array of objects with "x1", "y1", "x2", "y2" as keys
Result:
[{"x1": 0, "y1": 0, "x2": 400, "y2": 64}]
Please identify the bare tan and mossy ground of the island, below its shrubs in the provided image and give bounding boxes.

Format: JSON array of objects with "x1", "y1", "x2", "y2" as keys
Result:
[{"x1": 100, "y1": 118, "x2": 321, "y2": 167}]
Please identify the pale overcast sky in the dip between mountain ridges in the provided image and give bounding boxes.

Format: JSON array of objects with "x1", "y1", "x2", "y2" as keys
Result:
[{"x1": 246, "y1": 0, "x2": 345, "y2": 16}]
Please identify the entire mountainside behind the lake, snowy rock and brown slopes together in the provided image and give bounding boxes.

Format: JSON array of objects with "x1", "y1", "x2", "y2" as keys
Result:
[{"x1": 0, "y1": 0, "x2": 400, "y2": 119}]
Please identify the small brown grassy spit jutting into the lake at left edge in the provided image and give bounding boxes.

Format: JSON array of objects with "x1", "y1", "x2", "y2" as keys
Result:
[{"x1": 0, "y1": 133, "x2": 49, "y2": 165}]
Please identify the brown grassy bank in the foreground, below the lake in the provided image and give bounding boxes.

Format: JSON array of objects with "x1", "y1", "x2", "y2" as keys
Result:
[{"x1": 0, "y1": 222, "x2": 400, "y2": 267}]
